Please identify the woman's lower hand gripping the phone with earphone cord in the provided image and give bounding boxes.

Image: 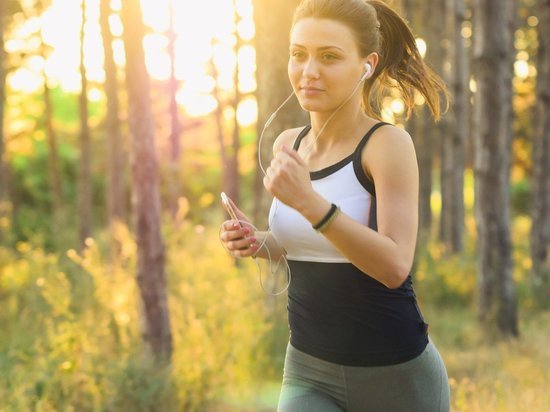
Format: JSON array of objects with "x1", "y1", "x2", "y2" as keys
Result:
[{"x1": 220, "y1": 199, "x2": 259, "y2": 258}]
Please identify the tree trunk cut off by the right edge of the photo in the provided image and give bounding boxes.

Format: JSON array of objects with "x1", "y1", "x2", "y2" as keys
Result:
[{"x1": 531, "y1": 0, "x2": 550, "y2": 307}]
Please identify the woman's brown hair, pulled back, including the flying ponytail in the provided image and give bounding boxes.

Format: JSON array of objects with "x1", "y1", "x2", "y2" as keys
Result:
[{"x1": 292, "y1": 0, "x2": 449, "y2": 120}]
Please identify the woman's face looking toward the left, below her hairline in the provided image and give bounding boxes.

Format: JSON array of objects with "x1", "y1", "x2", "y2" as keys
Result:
[{"x1": 288, "y1": 17, "x2": 367, "y2": 112}]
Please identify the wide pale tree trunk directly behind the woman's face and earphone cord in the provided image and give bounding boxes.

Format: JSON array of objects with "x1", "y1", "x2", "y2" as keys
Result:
[{"x1": 253, "y1": 0, "x2": 309, "y2": 226}]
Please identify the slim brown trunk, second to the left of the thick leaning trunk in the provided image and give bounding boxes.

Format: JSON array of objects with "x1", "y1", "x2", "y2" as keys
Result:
[{"x1": 78, "y1": 0, "x2": 92, "y2": 248}]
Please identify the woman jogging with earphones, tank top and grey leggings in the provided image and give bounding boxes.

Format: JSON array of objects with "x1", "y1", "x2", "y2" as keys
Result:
[{"x1": 221, "y1": 0, "x2": 450, "y2": 412}]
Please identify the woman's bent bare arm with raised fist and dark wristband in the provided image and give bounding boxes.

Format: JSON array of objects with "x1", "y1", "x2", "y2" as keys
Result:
[{"x1": 264, "y1": 127, "x2": 418, "y2": 288}]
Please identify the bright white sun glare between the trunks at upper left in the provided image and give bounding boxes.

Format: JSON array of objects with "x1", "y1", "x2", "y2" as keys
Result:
[{"x1": 6, "y1": 0, "x2": 257, "y2": 125}]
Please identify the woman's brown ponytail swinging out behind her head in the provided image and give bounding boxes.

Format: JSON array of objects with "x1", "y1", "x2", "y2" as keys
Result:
[{"x1": 363, "y1": 0, "x2": 449, "y2": 120}]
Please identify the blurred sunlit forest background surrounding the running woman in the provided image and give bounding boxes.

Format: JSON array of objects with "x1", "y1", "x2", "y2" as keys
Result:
[{"x1": 0, "y1": 0, "x2": 550, "y2": 412}]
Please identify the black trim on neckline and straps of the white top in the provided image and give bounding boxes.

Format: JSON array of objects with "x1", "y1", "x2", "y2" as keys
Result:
[{"x1": 292, "y1": 122, "x2": 390, "y2": 182}]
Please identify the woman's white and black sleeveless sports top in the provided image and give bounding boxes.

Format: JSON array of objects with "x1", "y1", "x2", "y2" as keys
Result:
[{"x1": 269, "y1": 122, "x2": 428, "y2": 366}]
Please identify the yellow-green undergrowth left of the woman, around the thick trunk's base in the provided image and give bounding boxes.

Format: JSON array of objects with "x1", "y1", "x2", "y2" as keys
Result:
[{"x1": 0, "y1": 214, "x2": 276, "y2": 411}]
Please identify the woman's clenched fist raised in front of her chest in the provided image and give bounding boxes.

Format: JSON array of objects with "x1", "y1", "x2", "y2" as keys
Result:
[{"x1": 264, "y1": 146, "x2": 315, "y2": 211}]
